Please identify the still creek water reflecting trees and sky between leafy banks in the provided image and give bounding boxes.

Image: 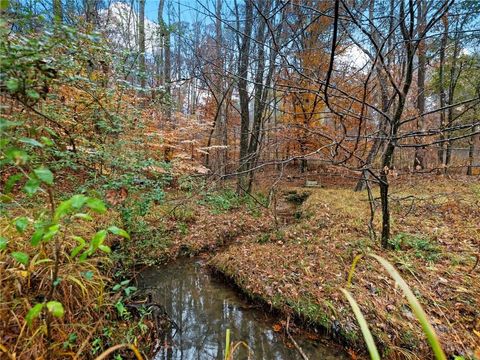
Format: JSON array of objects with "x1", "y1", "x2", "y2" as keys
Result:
[{"x1": 138, "y1": 259, "x2": 348, "y2": 360}]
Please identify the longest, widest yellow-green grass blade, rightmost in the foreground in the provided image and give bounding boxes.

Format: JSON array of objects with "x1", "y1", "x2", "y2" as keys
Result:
[{"x1": 370, "y1": 254, "x2": 447, "y2": 360}]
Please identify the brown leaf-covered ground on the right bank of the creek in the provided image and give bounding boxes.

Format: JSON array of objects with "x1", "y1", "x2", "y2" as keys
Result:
[{"x1": 140, "y1": 176, "x2": 480, "y2": 359}]
